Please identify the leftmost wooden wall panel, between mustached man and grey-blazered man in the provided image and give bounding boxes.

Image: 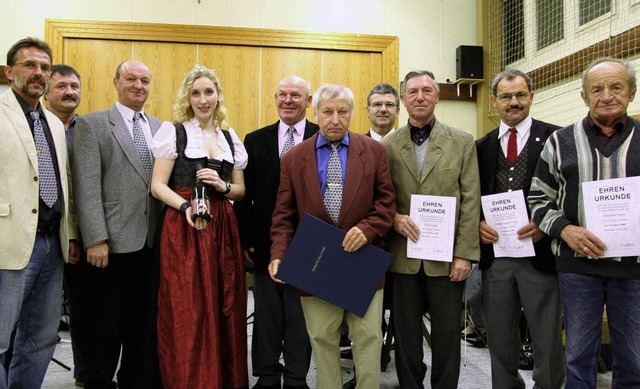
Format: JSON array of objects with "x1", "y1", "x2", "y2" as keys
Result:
[{"x1": 65, "y1": 39, "x2": 132, "y2": 114}]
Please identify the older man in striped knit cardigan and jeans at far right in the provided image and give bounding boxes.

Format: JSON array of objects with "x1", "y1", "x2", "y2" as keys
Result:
[{"x1": 528, "y1": 58, "x2": 640, "y2": 388}]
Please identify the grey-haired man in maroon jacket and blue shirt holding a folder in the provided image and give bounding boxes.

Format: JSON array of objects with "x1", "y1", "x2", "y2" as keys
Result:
[{"x1": 269, "y1": 85, "x2": 395, "y2": 389}]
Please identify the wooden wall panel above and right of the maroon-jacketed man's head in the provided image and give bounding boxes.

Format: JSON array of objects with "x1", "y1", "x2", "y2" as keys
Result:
[{"x1": 322, "y1": 51, "x2": 381, "y2": 133}]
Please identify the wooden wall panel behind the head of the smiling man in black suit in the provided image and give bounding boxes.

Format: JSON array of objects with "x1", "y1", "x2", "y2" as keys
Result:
[{"x1": 256, "y1": 47, "x2": 322, "y2": 128}]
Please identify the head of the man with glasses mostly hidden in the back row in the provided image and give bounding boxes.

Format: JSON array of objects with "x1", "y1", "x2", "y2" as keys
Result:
[{"x1": 367, "y1": 82, "x2": 400, "y2": 141}]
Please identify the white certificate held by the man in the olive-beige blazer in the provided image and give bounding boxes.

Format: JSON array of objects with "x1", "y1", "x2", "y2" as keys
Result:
[{"x1": 407, "y1": 195, "x2": 456, "y2": 262}]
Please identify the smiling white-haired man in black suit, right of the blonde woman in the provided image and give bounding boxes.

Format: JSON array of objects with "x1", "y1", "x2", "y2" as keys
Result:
[{"x1": 235, "y1": 76, "x2": 318, "y2": 389}]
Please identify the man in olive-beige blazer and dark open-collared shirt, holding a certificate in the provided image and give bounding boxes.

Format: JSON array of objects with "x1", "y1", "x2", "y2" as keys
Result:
[{"x1": 382, "y1": 70, "x2": 480, "y2": 389}]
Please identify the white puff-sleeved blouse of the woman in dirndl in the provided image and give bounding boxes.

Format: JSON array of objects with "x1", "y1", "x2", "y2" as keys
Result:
[{"x1": 151, "y1": 118, "x2": 248, "y2": 170}]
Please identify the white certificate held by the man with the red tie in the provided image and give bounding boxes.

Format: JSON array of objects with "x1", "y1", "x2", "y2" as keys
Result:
[{"x1": 481, "y1": 190, "x2": 536, "y2": 258}]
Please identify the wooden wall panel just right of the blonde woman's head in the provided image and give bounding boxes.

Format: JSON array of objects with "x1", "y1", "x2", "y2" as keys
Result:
[{"x1": 199, "y1": 45, "x2": 261, "y2": 139}]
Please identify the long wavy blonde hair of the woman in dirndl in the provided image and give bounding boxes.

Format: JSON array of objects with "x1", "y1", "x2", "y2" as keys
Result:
[{"x1": 173, "y1": 64, "x2": 229, "y2": 130}]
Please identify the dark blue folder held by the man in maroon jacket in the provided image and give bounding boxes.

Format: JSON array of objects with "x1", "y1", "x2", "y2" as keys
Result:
[{"x1": 276, "y1": 214, "x2": 392, "y2": 317}]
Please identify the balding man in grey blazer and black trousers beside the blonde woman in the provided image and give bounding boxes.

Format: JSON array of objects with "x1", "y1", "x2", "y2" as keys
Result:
[{"x1": 73, "y1": 60, "x2": 161, "y2": 389}]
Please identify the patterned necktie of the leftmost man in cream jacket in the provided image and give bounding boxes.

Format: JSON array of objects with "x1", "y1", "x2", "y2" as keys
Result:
[{"x1": 29, "y1": 111, "x2": 58, "y2": 208}]
